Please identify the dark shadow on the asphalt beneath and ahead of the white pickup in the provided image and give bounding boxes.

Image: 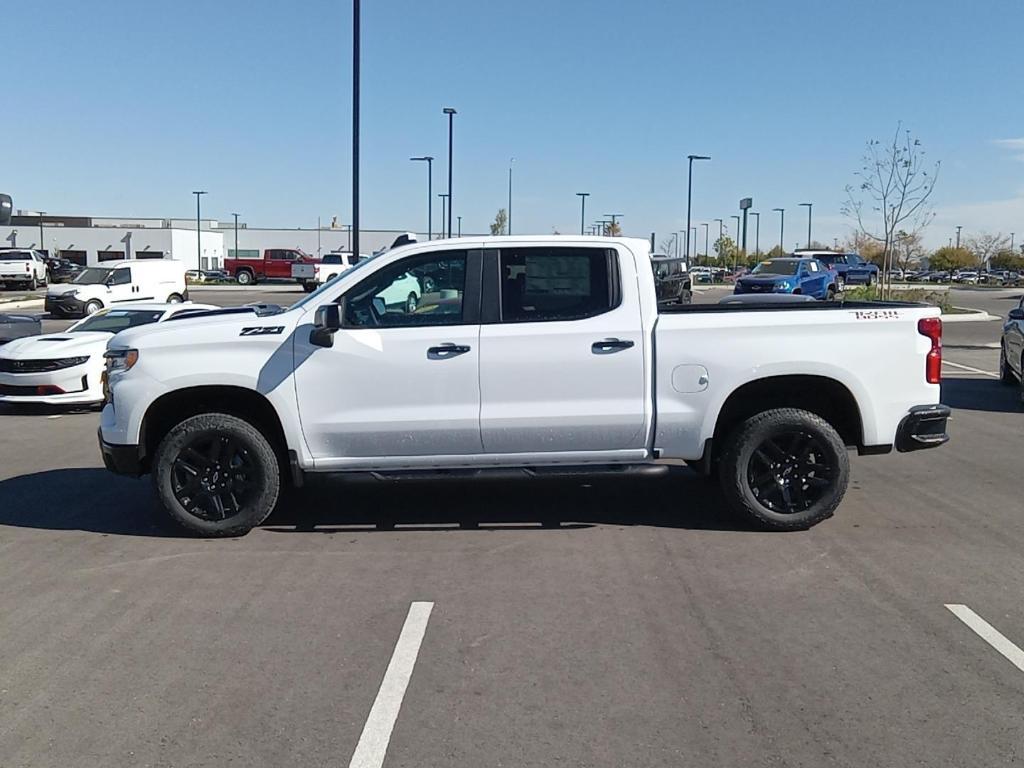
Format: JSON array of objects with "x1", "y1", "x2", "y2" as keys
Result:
[{"x1": 0, "y1": 467, "x2": 749, "y2": 537}]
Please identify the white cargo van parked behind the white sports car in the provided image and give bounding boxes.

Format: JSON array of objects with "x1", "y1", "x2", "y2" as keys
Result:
[{"x1": 46, "y1": 259, "x2": 188, "y2": 315}]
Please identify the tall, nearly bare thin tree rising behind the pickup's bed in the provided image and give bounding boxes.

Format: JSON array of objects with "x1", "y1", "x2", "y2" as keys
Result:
[{"x1": 843, "y1": 123, "x2": 940, "y2": 295}]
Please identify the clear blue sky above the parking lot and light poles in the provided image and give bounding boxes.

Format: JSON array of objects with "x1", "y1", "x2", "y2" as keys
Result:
[{"x1": 6, "y1": 0, "x2": 1024, "y2": 247}]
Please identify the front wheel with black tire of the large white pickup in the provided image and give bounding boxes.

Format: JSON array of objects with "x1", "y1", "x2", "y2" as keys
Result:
[{"x1": 153, "y1": 414, "x2": 281, "y2": 537}]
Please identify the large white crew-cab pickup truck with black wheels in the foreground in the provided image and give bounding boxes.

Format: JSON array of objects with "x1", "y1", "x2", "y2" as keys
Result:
[{"x1": 99, "y1": 237, "x2": 949, "y2": 536}]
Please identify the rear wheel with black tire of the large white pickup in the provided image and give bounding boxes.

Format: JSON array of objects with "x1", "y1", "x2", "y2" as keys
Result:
[{"x1": 719, "y1": 408, "x2": 850, "y2": 530}]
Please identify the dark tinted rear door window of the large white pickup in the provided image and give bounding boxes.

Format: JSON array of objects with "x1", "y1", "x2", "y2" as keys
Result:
[{"x1": 500, "y1": 248, "x2": 617, "y2": 323}]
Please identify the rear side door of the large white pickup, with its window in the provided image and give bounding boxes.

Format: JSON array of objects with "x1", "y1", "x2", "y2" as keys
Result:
[{"x1": 480, "y1": 248, "x2": 646, "y2": 454}]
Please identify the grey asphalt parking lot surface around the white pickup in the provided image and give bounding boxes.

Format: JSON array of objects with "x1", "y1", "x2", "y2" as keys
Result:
[{"x1": 0, "y1": 287, "x2": 1024, "y2": 768}]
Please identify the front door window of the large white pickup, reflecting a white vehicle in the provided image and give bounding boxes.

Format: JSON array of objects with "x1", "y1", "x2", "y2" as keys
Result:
[{"x1": 344, "y1": 251, "x2": 467, "y2": 328}]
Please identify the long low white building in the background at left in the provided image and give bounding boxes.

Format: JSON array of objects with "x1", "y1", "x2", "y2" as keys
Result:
[{"x1": 0, "y1": 211, "x2": 440, "y2": 269}]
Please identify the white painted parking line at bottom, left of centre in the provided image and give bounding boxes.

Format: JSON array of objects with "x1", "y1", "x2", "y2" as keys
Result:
[{"x1": 348, "y1": 602, "x2": 434, "y2": 768}]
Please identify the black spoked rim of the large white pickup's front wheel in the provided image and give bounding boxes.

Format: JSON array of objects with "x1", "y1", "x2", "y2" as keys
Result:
[{"x1": 171, "y1": 435, "x2": 262, "y2": 522}]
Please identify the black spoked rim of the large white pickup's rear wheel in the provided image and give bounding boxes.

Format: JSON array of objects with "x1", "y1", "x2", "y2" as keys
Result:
[{"x1": 746, "y1": 430, "x2": 836, "y2": 515}]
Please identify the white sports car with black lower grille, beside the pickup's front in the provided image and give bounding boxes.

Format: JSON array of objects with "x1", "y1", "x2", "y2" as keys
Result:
[{"x1": 0, "y1": 303, "x2": 217, "y2": 406}]
